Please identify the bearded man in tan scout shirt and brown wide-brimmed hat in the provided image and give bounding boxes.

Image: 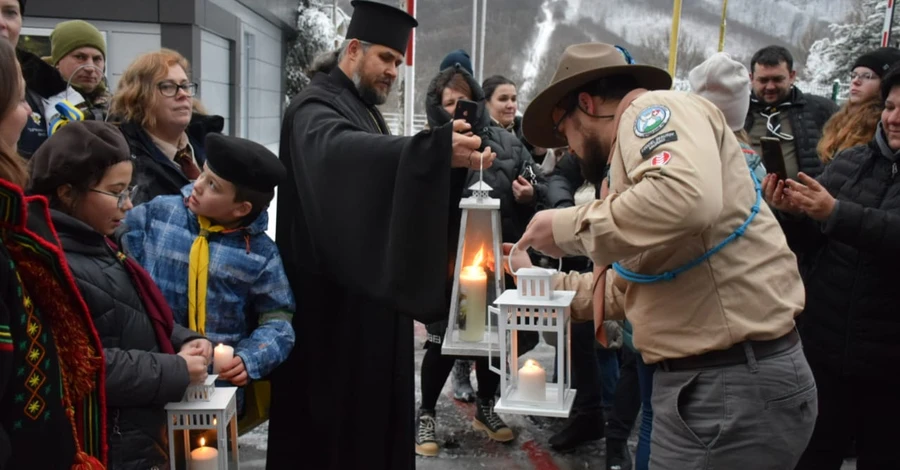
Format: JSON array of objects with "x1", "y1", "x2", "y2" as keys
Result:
[{"x1": 513, "y1": 43, "x2": 817, "y2": 469}]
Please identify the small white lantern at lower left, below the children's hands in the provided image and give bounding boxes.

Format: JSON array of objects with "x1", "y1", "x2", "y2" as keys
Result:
[{"x1": 166, "y1": 375, "x2": 240, "y2": 470}]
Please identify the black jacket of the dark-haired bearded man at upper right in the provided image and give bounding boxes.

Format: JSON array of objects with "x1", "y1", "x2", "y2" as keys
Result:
[{"x1": 744, "y1": 87, "x2": 838, "y2": 178}]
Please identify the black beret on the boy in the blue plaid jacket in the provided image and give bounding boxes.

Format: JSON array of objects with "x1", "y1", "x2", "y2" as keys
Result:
[{"x1": 206, "y1": 132, "x2": 287, "y2": 192}]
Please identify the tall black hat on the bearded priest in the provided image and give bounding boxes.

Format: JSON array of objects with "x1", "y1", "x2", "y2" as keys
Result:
[{"x1": 346, "y1": 0, "x2": 419, "y2": 54}]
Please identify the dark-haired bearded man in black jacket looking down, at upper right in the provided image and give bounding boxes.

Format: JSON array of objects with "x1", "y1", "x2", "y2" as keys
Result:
[{"x1": 744, "y1": 46, "x2": 838, "y2": 179}]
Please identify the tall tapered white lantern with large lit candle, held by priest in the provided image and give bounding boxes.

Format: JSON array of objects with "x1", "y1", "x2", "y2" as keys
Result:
[{"x1": 441, "y1": 178, "x2": 504, "y2": 356}]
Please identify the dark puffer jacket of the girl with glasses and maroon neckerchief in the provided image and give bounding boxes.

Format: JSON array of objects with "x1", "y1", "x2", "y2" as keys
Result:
[{"x1": 51, "y1": 210, "x2": 201, "y2": 470}]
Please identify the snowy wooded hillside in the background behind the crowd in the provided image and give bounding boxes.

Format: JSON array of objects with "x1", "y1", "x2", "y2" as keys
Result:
[{"x1": 329, "y1": 0, "x2": 858, "y2": 112}]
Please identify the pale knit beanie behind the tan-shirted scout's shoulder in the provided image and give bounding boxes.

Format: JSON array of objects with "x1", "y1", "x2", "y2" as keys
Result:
[{"x1": 688, "y1": 52, "x2": 750, "y2": 131}]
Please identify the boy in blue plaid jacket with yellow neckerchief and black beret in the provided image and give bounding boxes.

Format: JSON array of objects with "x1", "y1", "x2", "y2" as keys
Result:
[{"x1": 122, "y1": 133, "x2": 295, "y2": 387}]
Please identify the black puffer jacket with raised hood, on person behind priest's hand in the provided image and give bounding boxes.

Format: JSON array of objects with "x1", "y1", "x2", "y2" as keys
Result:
[{"x1": 425, "y1": 66, "x2": 547, "y2": 243}]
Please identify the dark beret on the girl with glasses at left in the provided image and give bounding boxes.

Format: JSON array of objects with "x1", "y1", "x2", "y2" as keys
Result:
[{"x1": 28, "y1": 121, "x2": 132, "y2": 196}]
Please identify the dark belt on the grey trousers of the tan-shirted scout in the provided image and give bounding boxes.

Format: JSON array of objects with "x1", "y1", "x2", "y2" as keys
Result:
[{"x1": 657, "y1": 328, "x2": 800, "y2": 372}]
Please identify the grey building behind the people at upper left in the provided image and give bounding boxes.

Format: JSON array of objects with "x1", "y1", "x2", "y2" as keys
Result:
[{"x1": 19, "y1": 0, "x2": 297, "y2": 148}]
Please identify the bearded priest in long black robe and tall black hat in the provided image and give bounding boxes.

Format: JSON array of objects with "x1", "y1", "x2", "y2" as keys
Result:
[{"x1": 266, "y1": 1, "x2": 495, "y2": 470}]
